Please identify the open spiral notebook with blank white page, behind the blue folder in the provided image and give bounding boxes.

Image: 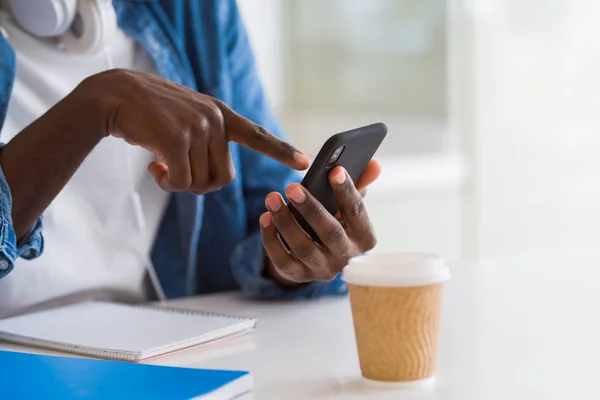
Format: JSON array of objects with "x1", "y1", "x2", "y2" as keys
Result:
[{"x1": 0, "y1": 302, "x2": 256, "y2": 362}]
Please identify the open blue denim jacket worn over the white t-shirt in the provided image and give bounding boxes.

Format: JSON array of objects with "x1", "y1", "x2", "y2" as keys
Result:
[{"x1": 0, "y1": 0, "x2": 346, "y2": 298}]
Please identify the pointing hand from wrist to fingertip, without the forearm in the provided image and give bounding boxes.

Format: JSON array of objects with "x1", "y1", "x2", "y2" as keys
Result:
[{"x1": 76, "y1": 69, "x2": 310, "y2": 194}]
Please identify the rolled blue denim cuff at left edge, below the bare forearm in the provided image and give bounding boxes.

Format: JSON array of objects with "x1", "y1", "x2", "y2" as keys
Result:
[{"x1": 0, "y1": 143, "x2": 44, "y2": 278}]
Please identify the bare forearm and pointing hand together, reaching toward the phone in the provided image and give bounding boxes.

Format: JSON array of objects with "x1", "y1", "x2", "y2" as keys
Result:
[{"x1": 0, "y1": 70, "x2": 309, "y2": 239}]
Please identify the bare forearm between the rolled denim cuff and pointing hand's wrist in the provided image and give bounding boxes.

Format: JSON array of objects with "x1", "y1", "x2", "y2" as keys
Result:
[{"x1": 0, "y1": 81, "x2": 106, "y2": 239}]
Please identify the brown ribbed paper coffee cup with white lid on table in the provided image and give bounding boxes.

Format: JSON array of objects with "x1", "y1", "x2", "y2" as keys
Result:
[{"x1": 343, "y1": 253, "x2": 450, "y2": 386}]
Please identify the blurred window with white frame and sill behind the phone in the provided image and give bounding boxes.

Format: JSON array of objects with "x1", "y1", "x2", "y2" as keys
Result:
[{"x1": 239, "y1": 0, "x2": 456, "y2": 164}]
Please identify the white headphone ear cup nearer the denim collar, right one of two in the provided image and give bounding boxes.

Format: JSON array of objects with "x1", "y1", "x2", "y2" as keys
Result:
[{"x1": 60, "y1": 0, "x2": 117, "y2": 54}]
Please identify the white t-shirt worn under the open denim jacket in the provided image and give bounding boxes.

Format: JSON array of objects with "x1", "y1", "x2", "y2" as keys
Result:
[{"x1": 0, "y1": 10, "x2": 168, "y2": 317}]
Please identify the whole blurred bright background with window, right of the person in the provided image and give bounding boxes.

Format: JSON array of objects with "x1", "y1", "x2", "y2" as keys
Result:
[{"x1": 239, "y1": 0, "x2": 600, "y2": 261}]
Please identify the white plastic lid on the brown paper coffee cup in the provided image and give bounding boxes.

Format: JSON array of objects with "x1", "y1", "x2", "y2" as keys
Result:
[{"x1": 343, "y1": 253, "x2": 450, "y2": 287}]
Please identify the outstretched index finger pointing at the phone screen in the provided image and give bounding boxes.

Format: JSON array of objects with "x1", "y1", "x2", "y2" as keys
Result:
[{"x1": 217, "y1": 102, "x2": 310, "y2": 170}]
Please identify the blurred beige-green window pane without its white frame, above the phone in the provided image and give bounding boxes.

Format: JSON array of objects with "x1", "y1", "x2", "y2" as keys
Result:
[{"x1": 286, "y1": 0, "x2": 446, "y2": 120}]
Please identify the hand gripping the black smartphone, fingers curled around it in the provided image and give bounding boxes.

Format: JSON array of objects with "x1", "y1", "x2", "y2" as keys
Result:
[{"x1": 260, "y1": 160, "x2": 381, "y2": 285}]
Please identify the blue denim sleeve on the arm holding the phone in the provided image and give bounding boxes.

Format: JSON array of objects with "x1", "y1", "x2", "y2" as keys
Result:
[{"x1": 225, "y1": 0, "x2": 346, "y2": 298}]
